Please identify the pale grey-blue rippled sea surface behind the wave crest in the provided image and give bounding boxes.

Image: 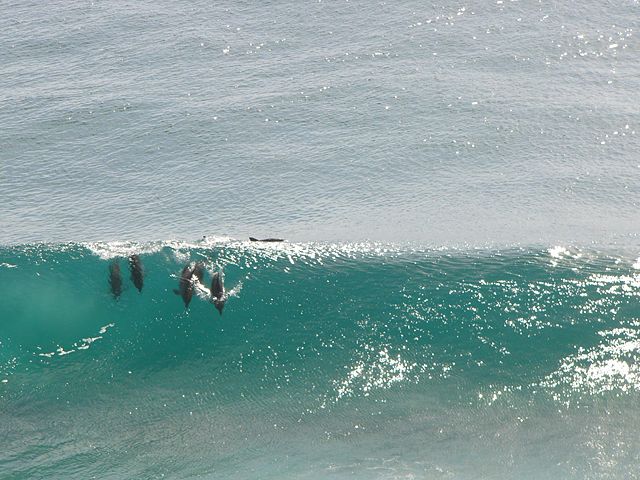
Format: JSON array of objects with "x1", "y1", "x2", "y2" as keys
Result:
[{"x1": 0, "y1": 0, "x2": 640, "y2": 245}]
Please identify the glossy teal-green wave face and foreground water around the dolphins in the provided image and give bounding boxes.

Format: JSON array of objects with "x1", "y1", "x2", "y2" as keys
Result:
[{"x1": 0, "y1": 240, "x2": 640, "y2": 478}]
